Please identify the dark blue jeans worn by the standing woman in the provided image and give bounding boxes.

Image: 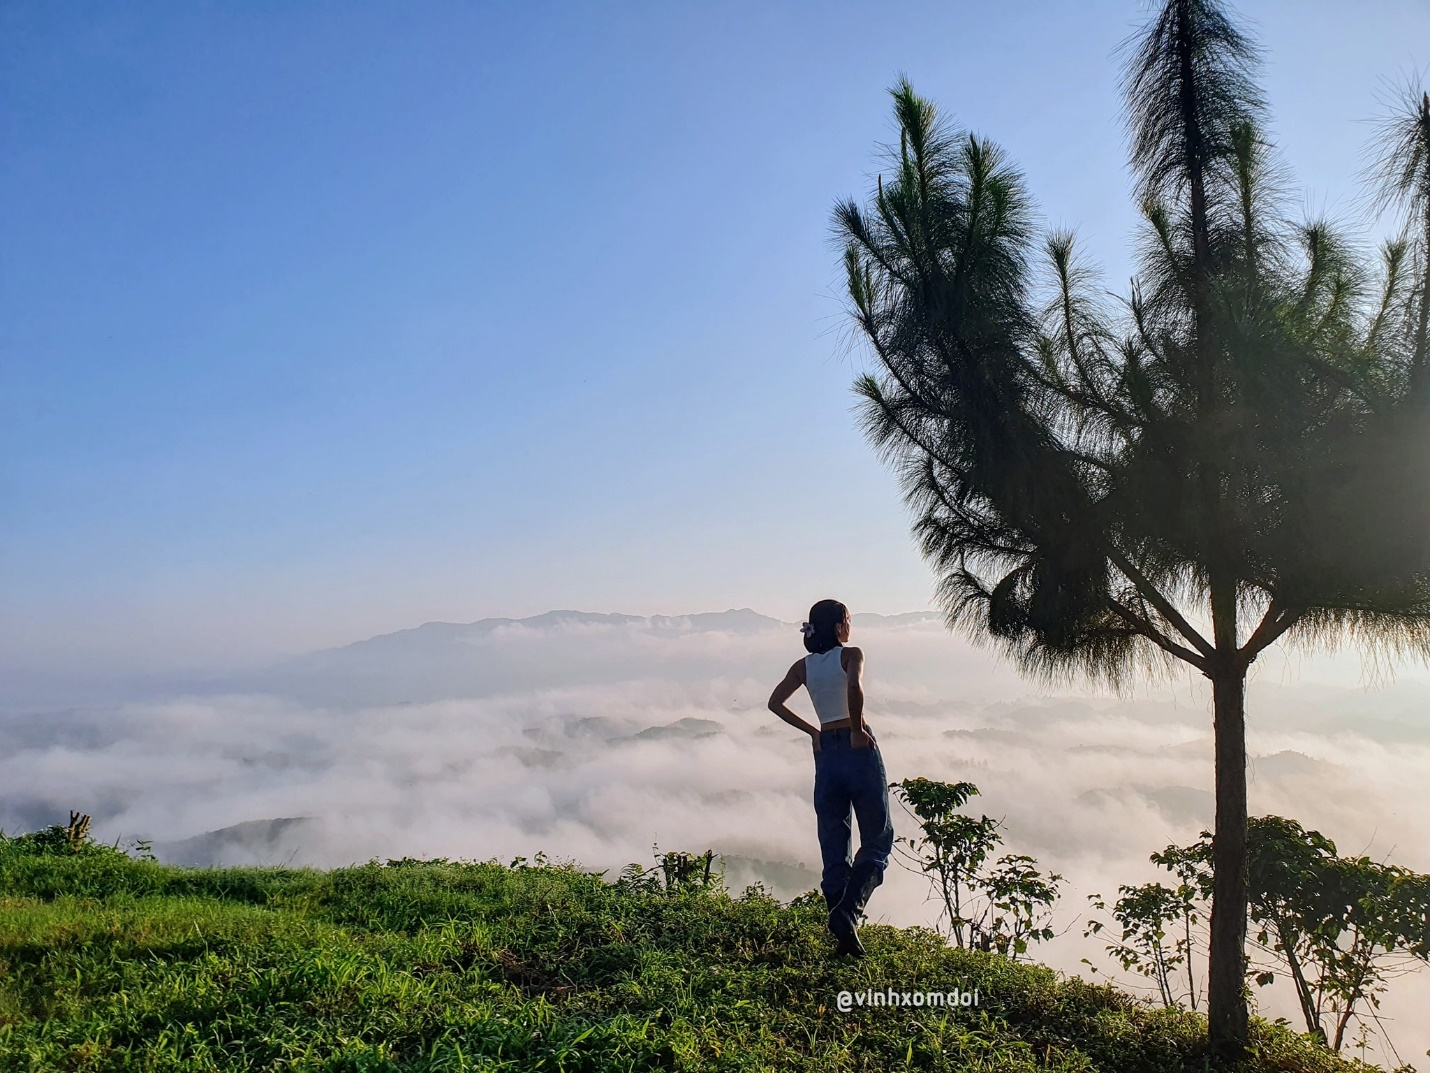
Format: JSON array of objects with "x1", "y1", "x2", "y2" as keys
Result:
[{"x1": 814, "y1": 727, "x2": 894, "y2": 903}]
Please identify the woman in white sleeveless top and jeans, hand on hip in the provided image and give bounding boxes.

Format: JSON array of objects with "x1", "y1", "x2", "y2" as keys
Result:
[{"x1": 769, "y1": 599, "x2": 894, "y2": 956}]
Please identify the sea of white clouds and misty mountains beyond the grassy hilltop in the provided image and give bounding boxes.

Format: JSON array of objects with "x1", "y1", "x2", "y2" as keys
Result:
[{"x1": 0, "y1": 609, "x2": 1430, "y2": 1062}]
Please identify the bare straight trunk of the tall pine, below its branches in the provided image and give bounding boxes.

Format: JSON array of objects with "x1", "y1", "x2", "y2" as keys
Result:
[{"x1": 1207, "y1": 652, "x2": 1248, "y2": 1064}]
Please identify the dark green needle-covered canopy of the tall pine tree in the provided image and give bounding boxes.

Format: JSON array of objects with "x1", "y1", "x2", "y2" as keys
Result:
[{"x1": 837, "y1": 79, "x2": 1430, "y2": 682}]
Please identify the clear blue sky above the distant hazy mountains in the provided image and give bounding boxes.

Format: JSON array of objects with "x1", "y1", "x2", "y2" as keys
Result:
[{"x1": 0, "y1": 0, "x2": 1430, "y2": 670}]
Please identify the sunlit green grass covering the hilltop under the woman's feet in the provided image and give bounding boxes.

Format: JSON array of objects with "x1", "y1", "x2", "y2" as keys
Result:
[{"x1": 0, "y1": 840, "x2": 1384, "y2": 1073}]
